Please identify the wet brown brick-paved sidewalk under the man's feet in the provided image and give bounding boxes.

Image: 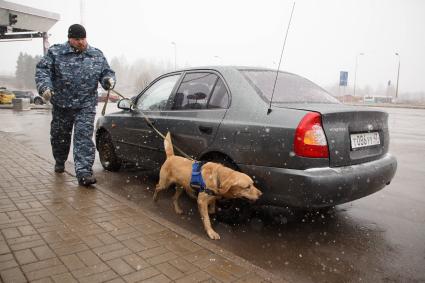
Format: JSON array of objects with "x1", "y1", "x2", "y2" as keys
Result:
[{"x1": 0, "y1": 132, "x2": 280, "y2": 283}]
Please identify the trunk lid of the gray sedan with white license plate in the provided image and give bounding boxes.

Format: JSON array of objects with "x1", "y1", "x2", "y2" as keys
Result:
[{"x1": 274, "y1": 104, "x2": 389, "y2": 167}]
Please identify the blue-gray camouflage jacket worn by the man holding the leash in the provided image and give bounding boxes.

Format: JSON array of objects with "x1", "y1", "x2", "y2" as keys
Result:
[{"x1": 35, "y1": 42, "x2": 115, "y2": 108}]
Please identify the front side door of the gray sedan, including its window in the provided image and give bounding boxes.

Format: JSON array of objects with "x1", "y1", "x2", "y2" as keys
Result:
[{"x1": 120, "y1": 73, "x2": 181, "y2": 169}]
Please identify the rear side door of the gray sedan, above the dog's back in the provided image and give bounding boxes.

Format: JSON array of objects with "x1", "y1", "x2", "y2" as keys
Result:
[{"x1": 160, "y1": 71, "x2": 229, "y2": 158}]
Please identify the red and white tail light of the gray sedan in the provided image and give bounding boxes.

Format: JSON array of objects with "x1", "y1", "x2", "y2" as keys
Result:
[{"x1": 294, "y1": 112, "x2": 329, "y2": 158}]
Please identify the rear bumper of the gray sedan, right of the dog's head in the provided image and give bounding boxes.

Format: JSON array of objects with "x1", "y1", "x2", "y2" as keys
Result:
[{"x1": 238, "y1": 154, "x2": 397, "y2": 208}]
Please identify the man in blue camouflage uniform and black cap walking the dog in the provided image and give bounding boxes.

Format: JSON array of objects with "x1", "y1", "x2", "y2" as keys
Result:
[{"x1": 35, "y1": 24, "x2": 115, "y2": 186}]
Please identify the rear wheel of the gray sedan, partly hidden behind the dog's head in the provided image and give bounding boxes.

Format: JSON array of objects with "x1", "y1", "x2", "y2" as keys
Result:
[{"x1": 205, "y1": 156, "x2": 254, "y2": 224}]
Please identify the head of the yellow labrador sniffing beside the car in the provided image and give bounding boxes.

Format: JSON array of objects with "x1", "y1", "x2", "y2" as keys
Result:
[{"x1": 204, "y1": 163, "x2": 262, "y2": 201}]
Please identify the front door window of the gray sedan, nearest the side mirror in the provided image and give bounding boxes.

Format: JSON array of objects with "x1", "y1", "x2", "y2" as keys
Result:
[{"x1": 136, "y1": 74, "x2": 180, "y2": 111}]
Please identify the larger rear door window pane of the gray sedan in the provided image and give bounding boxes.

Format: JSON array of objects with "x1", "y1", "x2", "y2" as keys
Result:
[{"x1": 172, "y1": 72, "x2": 218, "y2": 110}]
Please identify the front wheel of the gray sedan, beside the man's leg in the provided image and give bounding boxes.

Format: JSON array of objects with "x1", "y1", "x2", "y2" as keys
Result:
[{"x1": 97, "y1": 132, "x2": 121, "y2": 172}]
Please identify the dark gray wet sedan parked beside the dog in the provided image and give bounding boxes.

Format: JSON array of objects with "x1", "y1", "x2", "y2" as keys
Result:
[{"x1": 96, "y1": 67, "x2": 397, "y2": 208}]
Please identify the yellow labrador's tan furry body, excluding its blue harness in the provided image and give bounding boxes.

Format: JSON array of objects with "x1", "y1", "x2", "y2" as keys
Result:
[{"x1": 153, "y1": 133, "x2": 262, "y2": 240}]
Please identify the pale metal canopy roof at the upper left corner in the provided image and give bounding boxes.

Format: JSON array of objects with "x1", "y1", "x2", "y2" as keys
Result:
[{"x1": 0, "y1": 0, "x2": 60, "y2": 52}]
